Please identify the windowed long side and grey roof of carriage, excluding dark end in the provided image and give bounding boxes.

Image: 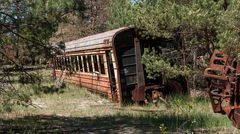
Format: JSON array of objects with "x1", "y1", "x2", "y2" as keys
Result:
[{"x1": 54, "y1": 27, "x2": 131, "y2": 102}]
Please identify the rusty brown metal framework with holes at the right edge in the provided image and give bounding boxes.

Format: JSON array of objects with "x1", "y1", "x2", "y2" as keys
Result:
[{"x1": 204, "y1": 50, "x2": 240, "y2": 128}]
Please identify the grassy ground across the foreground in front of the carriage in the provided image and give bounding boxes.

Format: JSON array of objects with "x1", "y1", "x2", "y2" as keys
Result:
[{"x1": 0, "y1": 69, "x2": 240, "y2": 134}]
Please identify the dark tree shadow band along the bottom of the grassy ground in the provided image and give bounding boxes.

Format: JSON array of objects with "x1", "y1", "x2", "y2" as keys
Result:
[{"x1": 0, "y1": 115, "x2": 230, "y2": 133}]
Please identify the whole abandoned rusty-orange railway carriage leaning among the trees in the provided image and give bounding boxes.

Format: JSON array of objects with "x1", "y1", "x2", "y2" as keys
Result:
[{"x1": 54, "y1": 27, "x2": 188, "y2": 102}]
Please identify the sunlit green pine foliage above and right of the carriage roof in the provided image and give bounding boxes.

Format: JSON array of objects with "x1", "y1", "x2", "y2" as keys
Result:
[{"x1": 109, "y1": 0, "x2": 240, "y2": 52}]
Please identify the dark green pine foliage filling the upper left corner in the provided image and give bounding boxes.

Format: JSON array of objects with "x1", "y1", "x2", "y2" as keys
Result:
[{"x1": 0, "y1": 0, "x2": 80, "y2": 65}]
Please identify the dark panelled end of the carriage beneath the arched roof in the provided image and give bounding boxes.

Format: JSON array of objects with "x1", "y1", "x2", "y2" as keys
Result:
[{"x1": 114, "y1": 31, "x2": 137, "y2": 101}]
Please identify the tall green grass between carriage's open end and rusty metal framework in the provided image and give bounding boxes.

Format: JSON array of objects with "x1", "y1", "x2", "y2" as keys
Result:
[{"x1": 118, "y1": 96, "x2": 233, "y2": 132}]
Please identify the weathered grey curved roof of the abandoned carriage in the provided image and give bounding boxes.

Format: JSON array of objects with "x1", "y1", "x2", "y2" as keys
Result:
[{"x1": 65, "y1": 27, "x2": 131, "y2": 52}]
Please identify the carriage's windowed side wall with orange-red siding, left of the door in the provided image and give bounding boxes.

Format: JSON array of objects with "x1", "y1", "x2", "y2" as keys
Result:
[{"x1": 55, "y1": 54, "x2": 112, "y2": 99}]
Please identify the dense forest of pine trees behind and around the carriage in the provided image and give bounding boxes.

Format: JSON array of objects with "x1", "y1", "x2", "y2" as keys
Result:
[{"x1": 0, "y1": 0, "x2": 240, "y2": 107}]
